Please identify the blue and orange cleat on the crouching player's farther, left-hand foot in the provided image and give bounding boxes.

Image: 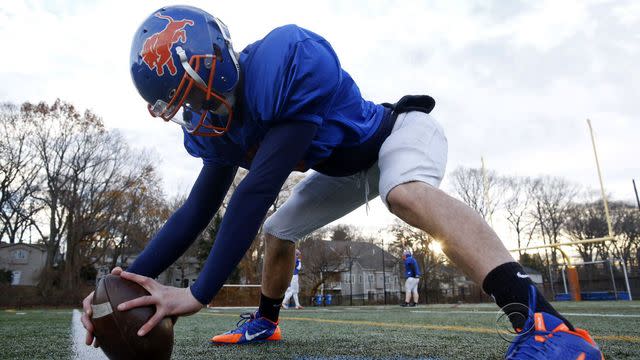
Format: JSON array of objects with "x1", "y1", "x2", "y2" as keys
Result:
[{"x1": 211, "y1": 311, "x2": 282, "y2": 345}]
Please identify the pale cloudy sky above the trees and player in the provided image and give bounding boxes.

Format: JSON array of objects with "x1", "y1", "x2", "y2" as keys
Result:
[{"x1": 0, "y1": 0, "x2": 640, "y2": 242}]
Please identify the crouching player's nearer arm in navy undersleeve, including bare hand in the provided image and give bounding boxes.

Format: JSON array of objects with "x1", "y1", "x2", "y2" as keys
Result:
[{"x1": 112, "y1": 121, "x2": 317, "y2": 336}]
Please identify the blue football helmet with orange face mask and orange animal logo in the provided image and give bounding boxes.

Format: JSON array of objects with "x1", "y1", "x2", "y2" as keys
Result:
[{"x1": 130, "y1": 6, "x2": 240, "y2": 136}]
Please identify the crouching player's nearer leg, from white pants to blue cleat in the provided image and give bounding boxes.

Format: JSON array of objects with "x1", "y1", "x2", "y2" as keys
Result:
[{"x1": 379, "y1": 112, "x2": 599, "y2": 358}]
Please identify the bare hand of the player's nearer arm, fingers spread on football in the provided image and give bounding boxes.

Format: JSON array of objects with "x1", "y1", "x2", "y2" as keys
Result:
[{"x1": 118, "y1": 271, "x2": 203, "y2": 336}]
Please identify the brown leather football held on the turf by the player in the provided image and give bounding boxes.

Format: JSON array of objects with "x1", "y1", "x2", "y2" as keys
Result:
[{"x1": 91, "y1": 275, "x2": 173, "y2": 360}]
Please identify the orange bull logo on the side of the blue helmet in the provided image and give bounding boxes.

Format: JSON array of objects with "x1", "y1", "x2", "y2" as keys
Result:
[{"x1": 140, "y1": 13, "x2": 194, "y2": 76}]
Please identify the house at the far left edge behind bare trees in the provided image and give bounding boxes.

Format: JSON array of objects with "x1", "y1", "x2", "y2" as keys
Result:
[{"x1": 0, "y1": 243, "x2": 47, "y2": 286}]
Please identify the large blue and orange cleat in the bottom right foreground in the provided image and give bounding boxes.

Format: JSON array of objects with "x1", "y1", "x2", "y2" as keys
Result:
[{"x1": 505, "y1": 285, "x2": 604, "y2": 360}]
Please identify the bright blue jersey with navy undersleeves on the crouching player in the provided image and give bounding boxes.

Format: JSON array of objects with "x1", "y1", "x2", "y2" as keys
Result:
[{"x1": 130, "y1": 25, "x2": 394, "y2": 304}]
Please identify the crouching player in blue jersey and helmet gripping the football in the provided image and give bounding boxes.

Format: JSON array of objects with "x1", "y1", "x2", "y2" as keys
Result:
[{"x1": 82, "y1": 6, "x2": 600, "y2": 359}]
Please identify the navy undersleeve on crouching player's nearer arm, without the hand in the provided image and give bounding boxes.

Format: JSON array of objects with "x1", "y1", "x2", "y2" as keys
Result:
[{"x1": 191, "y1": 121, "x2": 317, "y2": 304}]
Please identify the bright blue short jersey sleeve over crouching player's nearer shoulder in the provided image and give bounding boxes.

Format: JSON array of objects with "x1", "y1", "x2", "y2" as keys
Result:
[{"x1": 273, "y1": 39, "x2": 342, "y2": 126}]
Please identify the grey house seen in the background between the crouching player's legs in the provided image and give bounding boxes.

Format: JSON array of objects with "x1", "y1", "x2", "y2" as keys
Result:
[{"x1": 301, "y1": 240, "x2": 401, "y2": 301}]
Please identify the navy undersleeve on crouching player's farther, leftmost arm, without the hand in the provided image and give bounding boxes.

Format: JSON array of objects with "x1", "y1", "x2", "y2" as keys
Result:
[{"x1": 127, "y1": 165, "x2": 237, "y2": 278}]
